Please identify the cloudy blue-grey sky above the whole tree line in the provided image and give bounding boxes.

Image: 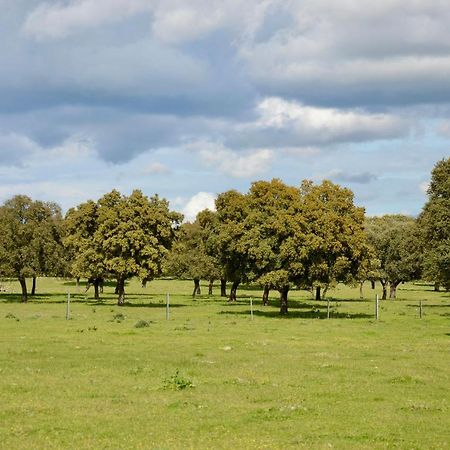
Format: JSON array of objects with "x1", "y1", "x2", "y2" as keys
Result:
[{"x1": 0, "y1": 0, "x2": 450, "y2": 220}]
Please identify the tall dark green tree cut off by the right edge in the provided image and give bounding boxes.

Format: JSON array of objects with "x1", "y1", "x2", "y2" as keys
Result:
[{"x1": 419, "y1": 158, "x2": 450, "y2": 290}]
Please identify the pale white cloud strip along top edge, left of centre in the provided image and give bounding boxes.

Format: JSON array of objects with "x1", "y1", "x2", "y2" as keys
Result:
[{"x1": 23, "y1": 0, "x2": 275, "y2": 44}]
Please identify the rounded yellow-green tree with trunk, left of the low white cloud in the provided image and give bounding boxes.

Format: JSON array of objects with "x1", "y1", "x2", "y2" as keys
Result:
[{"x1": 66, "y1": 190, "x2": 182, "y2": 304}]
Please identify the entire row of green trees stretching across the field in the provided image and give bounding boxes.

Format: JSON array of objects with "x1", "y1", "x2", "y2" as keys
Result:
[{"x1": 0, "y1": 159, "x2": 450, "y2": 314}]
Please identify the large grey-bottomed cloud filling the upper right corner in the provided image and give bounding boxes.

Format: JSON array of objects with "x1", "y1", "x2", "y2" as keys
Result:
[{"x1": 238, "y1": 0, "x2": 450, "y2": 104}]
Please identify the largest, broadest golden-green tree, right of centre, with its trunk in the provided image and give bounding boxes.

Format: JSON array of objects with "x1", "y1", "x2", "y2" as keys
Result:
[{"x1": 213, "y1": 179, "x2": 367, "y2": 313}]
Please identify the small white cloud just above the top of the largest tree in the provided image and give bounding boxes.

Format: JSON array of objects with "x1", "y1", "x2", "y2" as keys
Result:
[{"x1": 188, "y1": 140, "x2": 274, "y2": 178}]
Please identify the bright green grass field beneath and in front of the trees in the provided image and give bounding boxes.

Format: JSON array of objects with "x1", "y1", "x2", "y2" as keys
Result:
[{"x1": 0, "y1": 279, "x2": 450, "y2": 449}]
